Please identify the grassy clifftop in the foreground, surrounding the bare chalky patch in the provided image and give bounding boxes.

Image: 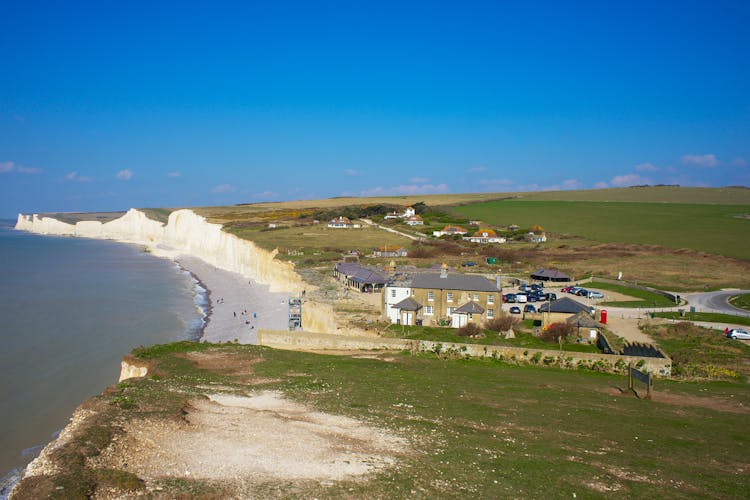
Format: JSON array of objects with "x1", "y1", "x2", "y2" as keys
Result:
[{"x1": 20, "y1": 343, "x2": 750, "y2": 498}]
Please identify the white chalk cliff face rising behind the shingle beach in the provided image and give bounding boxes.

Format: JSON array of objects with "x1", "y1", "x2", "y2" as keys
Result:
[{"x1": 16, "y1": 209, "x2": 336, "y2": 332}]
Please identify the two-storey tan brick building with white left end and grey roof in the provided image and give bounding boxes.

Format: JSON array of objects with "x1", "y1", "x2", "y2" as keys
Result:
[{"x1": 383, "y1": 265, "x2": 502, "y2": 328}]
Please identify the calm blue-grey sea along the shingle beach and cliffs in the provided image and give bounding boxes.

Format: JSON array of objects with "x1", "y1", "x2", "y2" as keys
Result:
[{"x1": 0, "y1": 219, "x2": 208, "y2": 498}]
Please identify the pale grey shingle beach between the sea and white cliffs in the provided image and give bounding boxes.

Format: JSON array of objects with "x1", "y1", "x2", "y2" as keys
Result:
[{"x1": 175, "y1": 255, "x2": 289, "y2": 344}]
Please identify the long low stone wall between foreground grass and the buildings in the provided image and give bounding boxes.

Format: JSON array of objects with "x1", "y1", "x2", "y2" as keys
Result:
[{"x1": 258, "y1": 330, "x2": 672, "y2": 377}]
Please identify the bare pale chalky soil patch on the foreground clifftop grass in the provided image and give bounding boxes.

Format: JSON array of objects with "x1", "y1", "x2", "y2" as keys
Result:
[{"x1": 100, "y1": 391, "x2": 408, "y2": 483}]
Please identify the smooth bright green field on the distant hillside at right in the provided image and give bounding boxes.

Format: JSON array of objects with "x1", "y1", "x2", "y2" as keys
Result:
[{"x1": 454, "y1": 200, "x2": 750, "y2": 259}]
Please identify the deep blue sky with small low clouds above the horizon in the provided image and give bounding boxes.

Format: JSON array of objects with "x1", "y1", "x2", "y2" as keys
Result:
[{"x1": 0, "y1": 0, "x2": 750, "y2": 217}]
